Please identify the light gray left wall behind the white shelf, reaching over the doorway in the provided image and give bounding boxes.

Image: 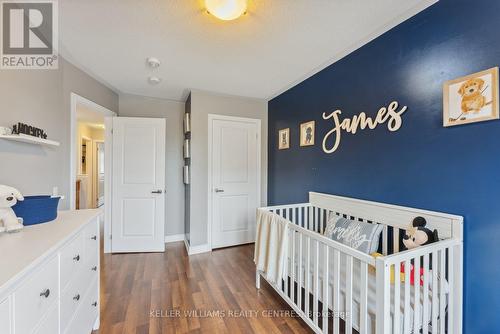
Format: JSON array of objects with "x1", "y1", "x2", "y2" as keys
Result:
[{"x1": 0, "y1": 58, "x2": 118, "y2": 209}]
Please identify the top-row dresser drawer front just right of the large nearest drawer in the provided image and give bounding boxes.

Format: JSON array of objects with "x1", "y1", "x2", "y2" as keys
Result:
[{"x1": 59, "y1": 232, "x2": 85, "y2": 291}]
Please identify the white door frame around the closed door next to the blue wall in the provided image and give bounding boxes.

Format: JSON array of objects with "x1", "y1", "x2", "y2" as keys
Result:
[{"x1": 207, "y1": 114, "x2": 262, "y2": 251}]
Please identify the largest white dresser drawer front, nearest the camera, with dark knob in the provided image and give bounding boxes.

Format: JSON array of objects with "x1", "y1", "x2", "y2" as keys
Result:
[{"x1": 14, "y1": 256, "x2": 59, "y2": 334}]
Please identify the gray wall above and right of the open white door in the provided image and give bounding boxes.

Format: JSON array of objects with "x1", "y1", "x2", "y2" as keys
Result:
[{"x1": 119, "y1": 95, "x2": 184, "y2": 235}]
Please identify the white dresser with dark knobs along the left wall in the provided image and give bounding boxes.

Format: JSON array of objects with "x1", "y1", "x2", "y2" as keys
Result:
[{"x1": 0, "y1": 210, "x2": 101, "y2": 334}]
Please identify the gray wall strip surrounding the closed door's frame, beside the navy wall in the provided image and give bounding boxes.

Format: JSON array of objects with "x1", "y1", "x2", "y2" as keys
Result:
[{"x1": 190, "y1": 90, "x2": 267, "y2": 246}]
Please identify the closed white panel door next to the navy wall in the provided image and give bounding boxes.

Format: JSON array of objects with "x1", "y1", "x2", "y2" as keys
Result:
[{"x1": 211, "y1": 117, "x2": 260, "y2": 248}]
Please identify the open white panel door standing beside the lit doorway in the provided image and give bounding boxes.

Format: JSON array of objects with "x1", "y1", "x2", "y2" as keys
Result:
[{"x1": 111, "y1": 117, "x2": 165, "y2": 253}]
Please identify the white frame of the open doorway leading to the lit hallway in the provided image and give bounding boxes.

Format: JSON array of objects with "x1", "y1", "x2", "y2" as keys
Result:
[{"x1": 68, "y1": 92, "x2": 117, "y2": 253}]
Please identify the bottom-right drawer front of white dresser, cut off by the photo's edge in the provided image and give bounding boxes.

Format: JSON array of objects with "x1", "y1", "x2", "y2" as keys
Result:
[{"x1": 61, "y1": 279, "x2": 99, "y2": 334}]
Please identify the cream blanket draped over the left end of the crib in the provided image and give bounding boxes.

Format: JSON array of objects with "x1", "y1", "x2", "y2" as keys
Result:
[{"x1": 254, "y1": 209, "x2": 290, "y2": 283}]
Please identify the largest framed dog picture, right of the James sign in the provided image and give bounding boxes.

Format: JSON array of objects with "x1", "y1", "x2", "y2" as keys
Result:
[{"x1": 443, "y1": 67, "x2": 499, "y2": 126}]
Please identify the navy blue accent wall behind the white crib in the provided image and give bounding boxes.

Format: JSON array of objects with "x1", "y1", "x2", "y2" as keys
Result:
[{"x1": 268, "y1": 0, "x2": 500, "y2": 334}]
